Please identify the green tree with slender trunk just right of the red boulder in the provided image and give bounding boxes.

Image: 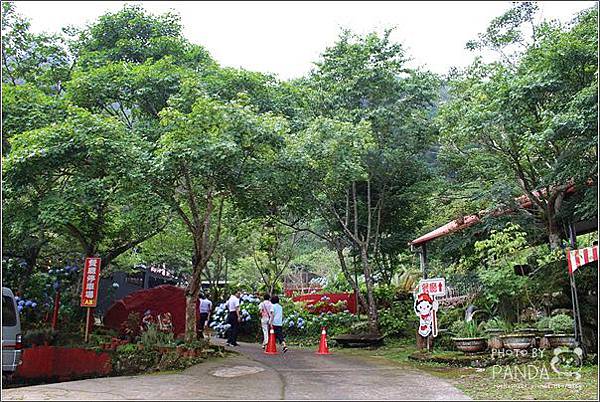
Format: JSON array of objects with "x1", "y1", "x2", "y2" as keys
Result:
[{"x1": 155, "y1": 97, "x2": 286, "y2": 340}]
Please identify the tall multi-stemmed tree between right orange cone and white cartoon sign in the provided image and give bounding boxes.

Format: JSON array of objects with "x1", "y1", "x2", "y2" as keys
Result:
[{"x1": 278, "y1": 30, "x2": 438, "y2": 332}]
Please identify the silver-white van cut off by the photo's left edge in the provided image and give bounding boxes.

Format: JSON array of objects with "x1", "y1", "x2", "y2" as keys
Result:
[{"x1": 2, "y1": 287, "x2": 23, "y2": 374}]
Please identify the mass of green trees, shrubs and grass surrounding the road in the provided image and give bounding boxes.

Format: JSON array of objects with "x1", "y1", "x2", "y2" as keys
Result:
[{"x1": 2, "y1": 2, "x2": 598, "y2": 399}]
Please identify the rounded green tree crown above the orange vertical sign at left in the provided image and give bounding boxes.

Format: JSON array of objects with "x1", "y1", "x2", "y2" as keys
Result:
[{"x1": 3, "y1": 108, "x2": 164, "y2": 266}]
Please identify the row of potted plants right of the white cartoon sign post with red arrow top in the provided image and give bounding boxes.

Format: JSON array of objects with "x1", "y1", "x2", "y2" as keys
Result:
[{"x1": 450, "y1": 314, "x2": 575, "y2": 353}]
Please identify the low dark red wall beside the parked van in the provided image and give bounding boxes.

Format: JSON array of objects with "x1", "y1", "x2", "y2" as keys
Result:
[{"x1": 15, "y1": 346, "x2": 112, "y2": 380}]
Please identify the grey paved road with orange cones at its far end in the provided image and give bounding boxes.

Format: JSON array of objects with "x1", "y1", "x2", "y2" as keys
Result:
[{"x1": 2, "y1": 341, "x2": 468, "y2": 400}]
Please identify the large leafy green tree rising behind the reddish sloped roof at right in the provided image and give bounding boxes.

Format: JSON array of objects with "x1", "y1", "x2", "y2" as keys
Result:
[{"x1": 440, "y1": 3, "x2": 598, "y2": 248}]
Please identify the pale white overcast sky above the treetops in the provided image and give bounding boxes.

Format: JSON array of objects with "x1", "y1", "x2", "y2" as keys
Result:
[{"x1": 16, "y1": 1, "x2": 595, "y2": 79}]
